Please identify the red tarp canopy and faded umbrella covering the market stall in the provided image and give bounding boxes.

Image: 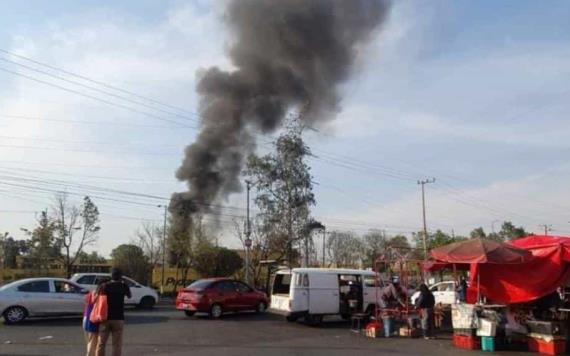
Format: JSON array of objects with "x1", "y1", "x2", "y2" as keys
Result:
[{"x1": 426, "y1": 235, "x2": 570, "y2": 303}]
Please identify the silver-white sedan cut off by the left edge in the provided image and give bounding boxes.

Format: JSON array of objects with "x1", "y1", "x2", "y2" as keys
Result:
[{"x1": 0, "y1": 278, "x2": 88, "y2": 324}]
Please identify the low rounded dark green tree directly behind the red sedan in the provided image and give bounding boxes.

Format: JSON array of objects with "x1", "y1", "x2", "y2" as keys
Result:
[{"x1": 194, "y1": 244, "x2": 243, "y2": 278}]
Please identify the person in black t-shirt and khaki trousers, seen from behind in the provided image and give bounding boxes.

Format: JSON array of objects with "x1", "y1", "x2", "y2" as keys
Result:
[{"x1": 97, "y1": 268, "x2": 131, "y2": 356}]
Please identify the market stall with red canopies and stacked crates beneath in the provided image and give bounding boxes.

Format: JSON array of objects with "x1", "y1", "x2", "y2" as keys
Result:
[{"x1": 424, "y1": 236, "x2": 570, "y2": 354}]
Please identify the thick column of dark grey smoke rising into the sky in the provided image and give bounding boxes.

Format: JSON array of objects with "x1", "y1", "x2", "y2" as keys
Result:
[{"x1": 170, "y1": 0, "x2": 388, "y2": 230}]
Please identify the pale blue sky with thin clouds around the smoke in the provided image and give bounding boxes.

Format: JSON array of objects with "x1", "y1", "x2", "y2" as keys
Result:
[{"x1": 0, "y1": 1, "x2": 570, "y2": 254}]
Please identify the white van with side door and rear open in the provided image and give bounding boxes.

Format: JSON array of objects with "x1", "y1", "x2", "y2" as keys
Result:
[{"x1": 269, "y1": 268, "x2": 376, "y2": 325}]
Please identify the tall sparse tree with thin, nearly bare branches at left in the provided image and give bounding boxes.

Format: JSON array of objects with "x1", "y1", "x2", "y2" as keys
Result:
[{"x1": 54, "y1": 193, "x2": 101, "y2": 278}]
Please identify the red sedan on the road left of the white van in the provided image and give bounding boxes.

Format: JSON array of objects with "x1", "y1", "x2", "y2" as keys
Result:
[{"x1": 176, "y1": 278, "x2": 268, "y2": 319}]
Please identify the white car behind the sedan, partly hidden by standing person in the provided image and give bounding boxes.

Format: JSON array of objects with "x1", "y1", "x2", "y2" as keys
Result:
[{"x1": 71, "y1": 273, "x2": 158, "y2": 309}]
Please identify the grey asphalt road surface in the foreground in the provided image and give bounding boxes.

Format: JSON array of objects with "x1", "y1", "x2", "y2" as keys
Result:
[{"x1": 0, "y1": 306, "x2": 516, "y2": 356}]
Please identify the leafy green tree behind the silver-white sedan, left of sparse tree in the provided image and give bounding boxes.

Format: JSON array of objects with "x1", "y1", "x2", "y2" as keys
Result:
[{"x1": 22, "y1": 211, "x2": 60, "y2": 275}]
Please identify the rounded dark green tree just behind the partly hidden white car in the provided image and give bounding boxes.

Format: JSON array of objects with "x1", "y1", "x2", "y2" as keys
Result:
[{"x1": 111, "y1": 244, "x2": 151, "y2": 284}]
